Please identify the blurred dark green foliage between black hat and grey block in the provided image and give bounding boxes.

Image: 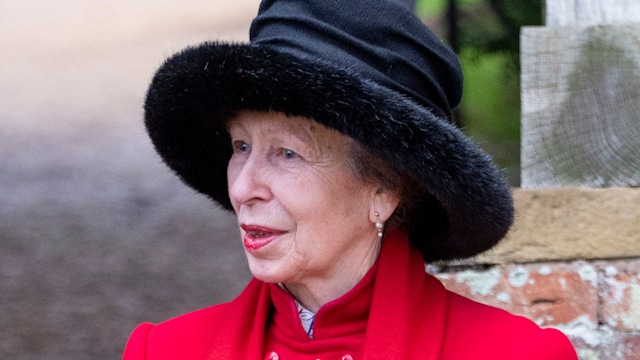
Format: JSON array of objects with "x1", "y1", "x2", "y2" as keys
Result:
[{"x1": 416, "y1": 0, "x2": 542, "y2": 185}]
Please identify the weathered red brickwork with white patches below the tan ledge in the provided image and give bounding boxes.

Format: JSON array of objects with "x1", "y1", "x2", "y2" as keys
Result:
[{"x1": 428, "y1": 259, "x2": 640, "y2": 360}]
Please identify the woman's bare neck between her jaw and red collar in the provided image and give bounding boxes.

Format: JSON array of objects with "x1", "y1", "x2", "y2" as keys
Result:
[{"x1": 283, "y1": 241, "x2": 381, "y2": 313}]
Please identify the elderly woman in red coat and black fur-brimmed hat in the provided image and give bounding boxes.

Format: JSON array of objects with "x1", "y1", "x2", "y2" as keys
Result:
[{"x1": 124, "y1": 0, "x2": 576, "y2": 360}]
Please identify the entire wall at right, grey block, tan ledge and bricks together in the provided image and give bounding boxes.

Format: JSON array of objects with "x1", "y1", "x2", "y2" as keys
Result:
[{"x1": 442, "y1": 0, "x2": 640, "y2": 360}]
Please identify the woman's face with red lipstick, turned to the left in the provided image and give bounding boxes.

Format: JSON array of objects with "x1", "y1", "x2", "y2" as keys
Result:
[{"x1": 227, "y1": 112, "x2": 379, "y2": 284}]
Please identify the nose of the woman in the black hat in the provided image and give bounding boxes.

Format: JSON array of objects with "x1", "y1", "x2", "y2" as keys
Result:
[{"x1": 227, "y1": 154, "x2": 271, "y2": 210}]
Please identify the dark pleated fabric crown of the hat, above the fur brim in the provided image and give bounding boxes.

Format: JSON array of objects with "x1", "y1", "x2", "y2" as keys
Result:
[{"x1": 250, "y1": 0, "x2": 462, "y2": 118}]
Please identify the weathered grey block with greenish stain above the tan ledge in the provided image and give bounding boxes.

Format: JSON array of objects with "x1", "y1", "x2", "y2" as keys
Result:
[{"x1": 521, "y1": 0, "x2": 640, "y2": 188}]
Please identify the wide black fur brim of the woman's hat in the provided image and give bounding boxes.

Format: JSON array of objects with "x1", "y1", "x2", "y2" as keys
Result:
[{"x1": 145, "y1": 42, "x2": 513, "y2": 261}]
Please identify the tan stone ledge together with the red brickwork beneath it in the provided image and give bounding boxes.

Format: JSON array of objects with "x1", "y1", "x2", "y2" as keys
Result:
[{"x1": 427, "y1": 188, "x2": 640, "y2": 360}]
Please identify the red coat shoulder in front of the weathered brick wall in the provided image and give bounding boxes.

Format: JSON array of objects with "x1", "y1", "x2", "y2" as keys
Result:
[{"x1": 443, "y1": 291, "x2": 578, "y2": 360}]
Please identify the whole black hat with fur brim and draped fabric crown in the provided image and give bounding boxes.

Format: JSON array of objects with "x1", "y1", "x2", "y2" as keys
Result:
[{"x1": 145, "y1": 0, "x2": 513, "y2": 261}]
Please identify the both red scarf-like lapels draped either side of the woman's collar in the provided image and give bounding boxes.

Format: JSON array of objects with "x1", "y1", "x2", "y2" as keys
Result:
[{"x1": 209, "y1": 231, "x2": 447, "y2": 360}]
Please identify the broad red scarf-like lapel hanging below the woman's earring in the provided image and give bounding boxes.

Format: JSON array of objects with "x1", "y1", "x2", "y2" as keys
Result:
[{"x1": 364, "y1": 231, "x2": 447, "y2": 360}]
